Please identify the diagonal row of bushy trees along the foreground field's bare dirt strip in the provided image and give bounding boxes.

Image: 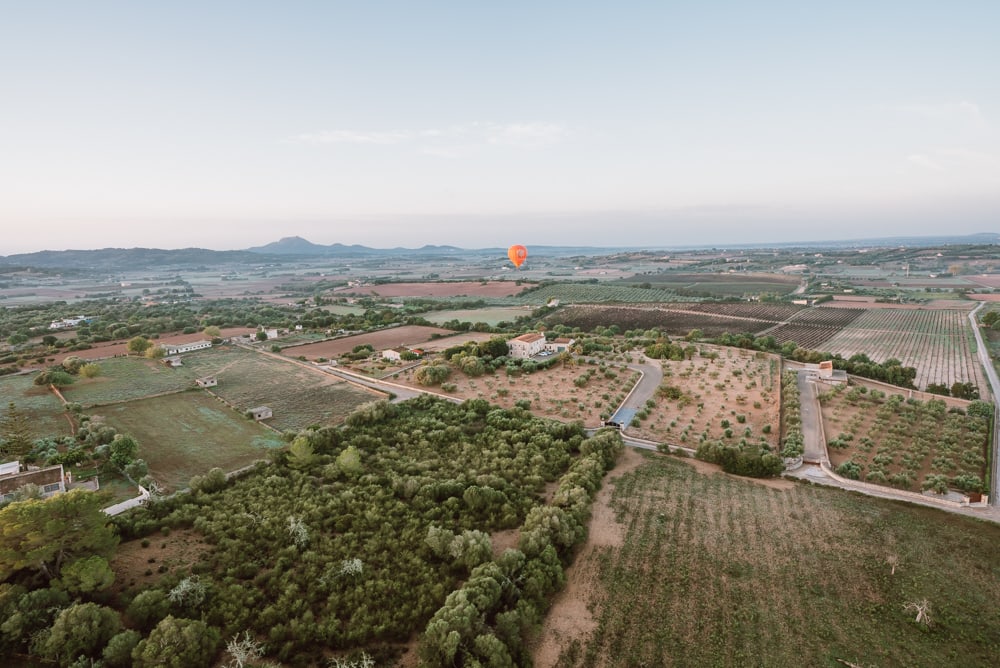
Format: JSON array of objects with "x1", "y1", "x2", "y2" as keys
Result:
[{"x1": 420, "y1": 431, "x2": 622, "y2": 666}]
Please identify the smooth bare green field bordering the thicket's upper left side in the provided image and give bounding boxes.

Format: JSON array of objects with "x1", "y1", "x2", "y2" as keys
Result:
[{"x1": 100, "y1": 390, "x2": 284, "y2": 490}]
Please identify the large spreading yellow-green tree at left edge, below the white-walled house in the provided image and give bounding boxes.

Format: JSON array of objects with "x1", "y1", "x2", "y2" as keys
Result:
[{"x1": 0, "y1": 489, "x2": 118, "y2": 581}]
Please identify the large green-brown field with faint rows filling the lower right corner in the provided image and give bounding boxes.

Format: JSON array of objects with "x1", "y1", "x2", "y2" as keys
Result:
[{"x1": 558, "y1": 457, "x2": 1000, "y2": 668}]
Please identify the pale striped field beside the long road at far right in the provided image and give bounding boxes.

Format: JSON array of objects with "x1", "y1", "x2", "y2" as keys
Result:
[{"x1": 821, "y1": 309, "x2": 987, "y2": 392}]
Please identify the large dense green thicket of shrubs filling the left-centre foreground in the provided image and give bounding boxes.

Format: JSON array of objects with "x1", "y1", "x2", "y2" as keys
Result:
[{"x1": 95, "y1": 397, "x2": 592, "y2": 661}]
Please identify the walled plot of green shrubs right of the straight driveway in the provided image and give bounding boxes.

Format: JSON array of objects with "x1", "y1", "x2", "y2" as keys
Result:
[{"x1": 820, "y1": 386, "x2": 990, "y2": 492}]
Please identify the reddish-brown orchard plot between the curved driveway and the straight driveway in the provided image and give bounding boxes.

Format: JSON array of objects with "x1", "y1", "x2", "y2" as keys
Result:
[{"x1": 629, "y1": 346, "x2": 781, "y2": 448}]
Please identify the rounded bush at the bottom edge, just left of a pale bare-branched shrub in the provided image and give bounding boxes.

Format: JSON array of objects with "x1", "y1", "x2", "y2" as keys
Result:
[{"x1": 132, "y1": 615, "x2": 219, "y2": 668}]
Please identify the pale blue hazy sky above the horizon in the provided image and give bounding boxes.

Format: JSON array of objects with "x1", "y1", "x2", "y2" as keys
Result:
[{"x1": 0, "y1": 0, "x2": 1000, "y2": 255}]
